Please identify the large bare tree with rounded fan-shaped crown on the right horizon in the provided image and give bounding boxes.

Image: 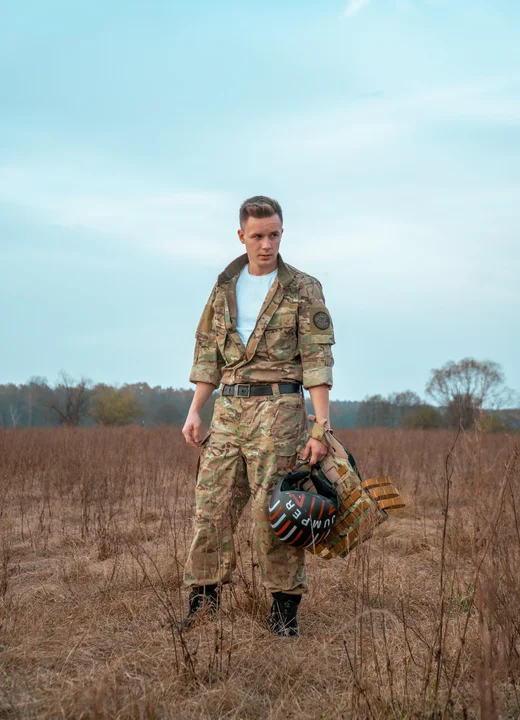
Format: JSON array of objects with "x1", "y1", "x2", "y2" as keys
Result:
[{"x1": 426, "y1": 358, "x2": 510, "y2": 427}]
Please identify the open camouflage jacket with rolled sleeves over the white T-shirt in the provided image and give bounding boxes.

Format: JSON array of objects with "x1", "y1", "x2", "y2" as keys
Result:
[{"x1": 190, "y1": 254, "x2": 334, "y2": 388}]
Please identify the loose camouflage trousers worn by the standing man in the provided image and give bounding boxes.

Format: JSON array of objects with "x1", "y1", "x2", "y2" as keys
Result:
[{"x1": 184, "y1": 393, "x2": 307, "y2": 594}]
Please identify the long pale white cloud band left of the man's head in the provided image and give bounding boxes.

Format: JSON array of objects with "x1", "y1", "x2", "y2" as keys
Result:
[{"x1": 0, "y1": 167, "x2": 238, "y2": 262}]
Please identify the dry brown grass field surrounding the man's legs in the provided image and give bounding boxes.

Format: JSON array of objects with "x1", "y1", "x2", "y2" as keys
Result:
[{"x1": 0, "y1": 427, "x2": 520, "y2": 720}]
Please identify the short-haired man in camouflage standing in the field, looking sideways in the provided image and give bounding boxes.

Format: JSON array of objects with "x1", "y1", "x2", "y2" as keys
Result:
[{"x1": 183, "y1": 196, "x2": 334, "y2": 636}]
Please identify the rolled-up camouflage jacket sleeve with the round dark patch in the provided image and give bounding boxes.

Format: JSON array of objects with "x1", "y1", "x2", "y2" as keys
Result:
[{"x1": 298, "y1": 278, "x2": 335, "y2": 389}]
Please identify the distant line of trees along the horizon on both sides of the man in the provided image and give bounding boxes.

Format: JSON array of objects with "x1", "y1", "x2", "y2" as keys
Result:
[{"x1": 0, "y1": 358, "x2": 520, "y2": 430}]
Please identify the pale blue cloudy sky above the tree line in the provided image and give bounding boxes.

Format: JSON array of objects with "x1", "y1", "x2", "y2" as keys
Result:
[{"x1": 0, "y1": 0, "x2": 520, "y2": 399}]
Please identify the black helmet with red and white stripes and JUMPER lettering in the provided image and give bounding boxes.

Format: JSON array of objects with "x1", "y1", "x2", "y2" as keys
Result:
[{"x1": 269, "y1": 463, "x2": 339, "y2": 547}]
